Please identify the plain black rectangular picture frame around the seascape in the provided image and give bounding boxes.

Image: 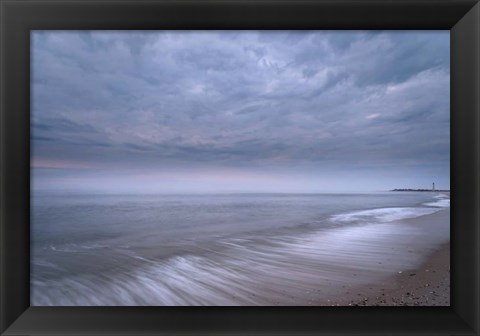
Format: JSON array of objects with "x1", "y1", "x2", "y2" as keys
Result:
[{"x1": 0, "y1": 0, "x2": 480, "y2": 335}]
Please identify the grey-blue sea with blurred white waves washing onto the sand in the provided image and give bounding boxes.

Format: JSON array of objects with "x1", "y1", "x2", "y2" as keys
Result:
[{"x1": 31, "y1": 192, "x2": 450, "y2": 306}]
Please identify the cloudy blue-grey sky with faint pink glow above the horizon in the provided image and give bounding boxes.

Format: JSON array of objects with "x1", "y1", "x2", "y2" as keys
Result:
[{"x1": 31, "y1": 31, "x2": 450, "y2": 193}]
